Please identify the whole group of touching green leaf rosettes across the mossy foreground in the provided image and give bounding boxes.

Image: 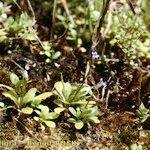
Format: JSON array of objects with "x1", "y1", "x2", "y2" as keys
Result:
[{"x1": 0, "y1": 72, "x2": 99, "y2": 129}]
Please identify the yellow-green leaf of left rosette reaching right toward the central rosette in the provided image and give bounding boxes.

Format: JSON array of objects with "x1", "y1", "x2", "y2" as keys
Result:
[{"x1": 32, "y1": 92, "x2": 53, "y2": 106}]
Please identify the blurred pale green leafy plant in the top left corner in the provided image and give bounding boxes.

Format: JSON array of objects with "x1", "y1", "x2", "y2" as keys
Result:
[{"x1": 0, "y1": 2, "x2": 37, "y2": 42}]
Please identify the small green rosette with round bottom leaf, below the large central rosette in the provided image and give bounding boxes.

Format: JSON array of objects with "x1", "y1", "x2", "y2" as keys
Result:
[{"x1": 68, "y1": 105, "x2": 100, "y2": 130}]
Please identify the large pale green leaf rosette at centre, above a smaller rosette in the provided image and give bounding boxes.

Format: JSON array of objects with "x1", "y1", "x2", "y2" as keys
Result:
[{"x1": 53, "y1": 81, "x2": 94, "y2": 108}]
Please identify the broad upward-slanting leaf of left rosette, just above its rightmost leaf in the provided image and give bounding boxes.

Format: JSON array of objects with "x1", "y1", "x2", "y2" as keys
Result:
[{"x1": 22, "y1": 88, "x2": 37, "y2": 105}]
